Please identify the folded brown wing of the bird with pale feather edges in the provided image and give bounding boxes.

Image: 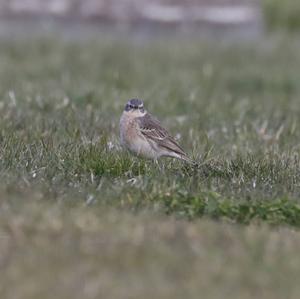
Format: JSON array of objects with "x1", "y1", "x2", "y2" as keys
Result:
[{"x1": 137, "y1": 113, "x2": 186, "y2": 157}]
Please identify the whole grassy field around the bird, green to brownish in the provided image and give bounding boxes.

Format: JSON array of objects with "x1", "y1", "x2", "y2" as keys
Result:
[{"x1": 0, "y1": 34, "x2": 300, "y2": 299}]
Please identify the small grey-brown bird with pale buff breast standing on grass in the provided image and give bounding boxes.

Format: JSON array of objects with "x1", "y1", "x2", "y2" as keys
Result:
[{"x1": 120, "y1": 98, "x2": 194, "y2": 164}]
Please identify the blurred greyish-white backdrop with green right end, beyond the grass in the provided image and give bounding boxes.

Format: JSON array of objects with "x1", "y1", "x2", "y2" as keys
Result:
[{"x1": 0, "y1": 0, "x2": 300, "y2": 40}]
